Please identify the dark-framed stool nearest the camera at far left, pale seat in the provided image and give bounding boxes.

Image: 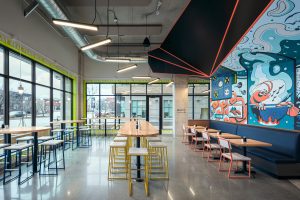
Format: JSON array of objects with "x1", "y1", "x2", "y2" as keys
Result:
[{"x1": 3, "y1": 143, "x2": 33, "y2": 185}]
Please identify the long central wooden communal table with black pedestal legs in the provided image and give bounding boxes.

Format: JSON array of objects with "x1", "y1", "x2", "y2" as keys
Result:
[{"x1": 119, "y1": 120, "x2": 159, "y2": 181}]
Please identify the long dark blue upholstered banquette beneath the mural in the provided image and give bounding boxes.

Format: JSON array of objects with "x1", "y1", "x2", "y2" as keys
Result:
[{"x1": 209, "y1": 121, "x2": 300, "y2": 178}]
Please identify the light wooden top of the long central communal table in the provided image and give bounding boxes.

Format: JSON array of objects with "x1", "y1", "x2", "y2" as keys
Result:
[{"x1": 119, "y1": 120, "x2": 159, "y2": 137}]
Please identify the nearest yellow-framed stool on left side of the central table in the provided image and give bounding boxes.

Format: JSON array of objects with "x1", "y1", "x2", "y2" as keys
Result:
[{"x1": 108, "y1": 142, "x2": 128, "y2": 180}]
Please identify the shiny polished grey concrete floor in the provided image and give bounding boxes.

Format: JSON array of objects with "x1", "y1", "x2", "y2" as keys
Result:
[{"x1": 0, "y1": 137, "x2": 300, "y2": 200}]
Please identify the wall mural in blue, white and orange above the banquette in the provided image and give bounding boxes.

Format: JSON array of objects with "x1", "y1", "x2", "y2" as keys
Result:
[{"x1": 211, "y1": 0, "x2": 300, "y2": 130}]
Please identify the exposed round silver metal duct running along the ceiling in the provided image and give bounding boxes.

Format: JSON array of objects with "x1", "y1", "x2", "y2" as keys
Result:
[{"x1": 37, "y1": 0, "x2": 148, "y2": 63}]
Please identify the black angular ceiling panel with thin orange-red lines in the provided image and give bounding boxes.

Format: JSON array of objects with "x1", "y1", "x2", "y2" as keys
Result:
[{"x1": 148, "y1": 0, "x2": 273, "y2": 77}]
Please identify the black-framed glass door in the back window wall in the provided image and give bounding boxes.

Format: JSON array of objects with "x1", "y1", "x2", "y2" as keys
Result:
[{"x1": 146, "y1": 96, "x2": 162, "y2": 134}]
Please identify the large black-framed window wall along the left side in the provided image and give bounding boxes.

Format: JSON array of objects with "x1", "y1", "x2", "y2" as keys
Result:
[{"x1": 0, "y1": 46, "x2": 73, "y2": 127}]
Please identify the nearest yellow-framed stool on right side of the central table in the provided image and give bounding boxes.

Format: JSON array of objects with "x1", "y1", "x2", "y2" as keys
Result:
[{"x1": 149, "y1": 142, "x2": 169, "y2": 180}]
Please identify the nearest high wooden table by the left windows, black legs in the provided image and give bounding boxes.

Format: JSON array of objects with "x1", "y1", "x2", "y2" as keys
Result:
[{"x1": 0, "y1": 126, "x2": 51, "y2": 173}]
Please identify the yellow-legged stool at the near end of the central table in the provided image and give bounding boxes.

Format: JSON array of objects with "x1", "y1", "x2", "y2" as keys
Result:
[{"x1": 128, "y1": 147, "x2": 149, "y2": 196}]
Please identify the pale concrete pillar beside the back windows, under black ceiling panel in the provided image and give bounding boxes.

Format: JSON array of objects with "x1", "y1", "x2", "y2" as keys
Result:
[{"x1": 173, "y1": 76, "x2": 188, "y2": 136}]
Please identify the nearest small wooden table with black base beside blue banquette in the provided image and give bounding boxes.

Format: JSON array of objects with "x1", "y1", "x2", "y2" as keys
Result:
[{"x1": 229, "y1": 139, "x2": 272, "y2": 173}]
